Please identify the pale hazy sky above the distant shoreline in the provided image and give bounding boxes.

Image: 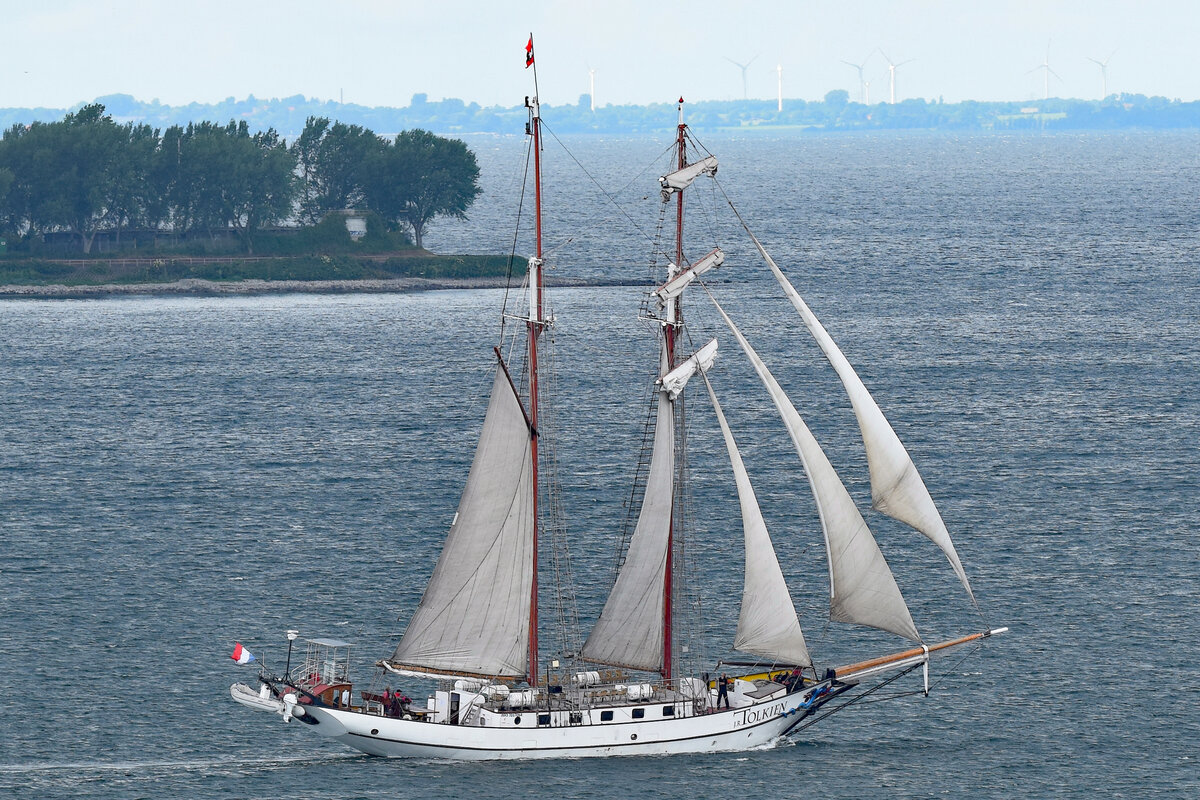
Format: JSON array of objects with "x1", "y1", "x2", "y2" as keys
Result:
[{"x1": 0, "y1": 0, "x2": 1200, "y2": 108}]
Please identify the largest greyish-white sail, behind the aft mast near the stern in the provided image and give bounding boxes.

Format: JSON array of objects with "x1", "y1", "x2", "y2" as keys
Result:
[{"x1": 391, "y1": 368, "x2": 534, "y2": 678}]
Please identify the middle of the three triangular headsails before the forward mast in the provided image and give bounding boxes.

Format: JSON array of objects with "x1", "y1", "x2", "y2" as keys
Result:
[{"x1": 713, "y1": 299, "x2": 920, "y2": 642}]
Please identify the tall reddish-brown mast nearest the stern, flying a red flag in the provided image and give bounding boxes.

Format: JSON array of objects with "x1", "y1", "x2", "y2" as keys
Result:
[{"x1": 526, "y1": 34, "x2": 545, "y2": 686}]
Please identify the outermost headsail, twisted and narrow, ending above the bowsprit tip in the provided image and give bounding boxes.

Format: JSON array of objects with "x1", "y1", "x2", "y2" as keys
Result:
[{"x1": 750, "y1": 227, "x2": 974, "y2": 602}]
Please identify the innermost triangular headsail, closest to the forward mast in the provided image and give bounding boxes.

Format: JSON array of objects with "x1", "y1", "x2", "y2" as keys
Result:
[{"x1": 701, "y1": 373, "x2": 812, "y2": 667}]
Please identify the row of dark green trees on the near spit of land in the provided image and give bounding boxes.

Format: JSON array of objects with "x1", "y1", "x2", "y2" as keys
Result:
[{"x1": 0, "y1": 103, "x2": 480, "y2": 253}]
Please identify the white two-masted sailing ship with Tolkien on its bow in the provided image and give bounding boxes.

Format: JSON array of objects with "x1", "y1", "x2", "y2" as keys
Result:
[{"x1": 230, "y1": 37, "x2": 1007, "y2": 759}]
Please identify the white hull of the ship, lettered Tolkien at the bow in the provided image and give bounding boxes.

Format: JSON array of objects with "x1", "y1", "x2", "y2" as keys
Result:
[{"x1": 292, "y1": 692, "x2": 805, "y2": 760}]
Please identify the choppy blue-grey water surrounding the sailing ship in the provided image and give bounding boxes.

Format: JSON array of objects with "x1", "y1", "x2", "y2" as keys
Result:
[{"x1": 0, "y1": 134, "x2": 1200, "y2": 800}]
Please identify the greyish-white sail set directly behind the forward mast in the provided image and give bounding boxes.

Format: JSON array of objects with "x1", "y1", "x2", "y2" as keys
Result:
[{"x1": 583, "y1": 391, "x2": 674, "y2": 670}]
